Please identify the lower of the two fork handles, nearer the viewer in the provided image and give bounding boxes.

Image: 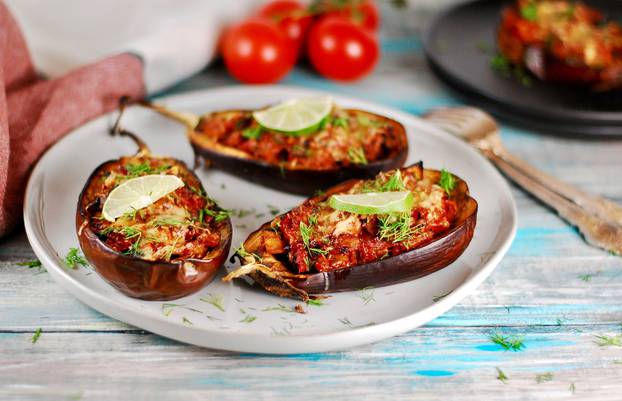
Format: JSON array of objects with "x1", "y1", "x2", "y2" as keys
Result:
[{"x1": 486, "y1": 152, "x2": 622, "y2": 254}]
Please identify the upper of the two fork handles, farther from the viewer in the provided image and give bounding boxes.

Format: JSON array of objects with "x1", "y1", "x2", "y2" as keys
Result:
[{"x1": 486, "y1": 148, "x2": 622, "y2": 226}]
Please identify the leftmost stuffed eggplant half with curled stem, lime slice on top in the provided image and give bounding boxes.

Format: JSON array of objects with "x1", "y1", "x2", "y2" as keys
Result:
[{"x1": 76, "y1": 111, "x2": 232, "y2": 300}]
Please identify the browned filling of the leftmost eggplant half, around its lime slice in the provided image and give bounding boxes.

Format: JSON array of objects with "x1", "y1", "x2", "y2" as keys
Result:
[{"x1": 85, "y1": 156, "x2": 228, "y2": 262}]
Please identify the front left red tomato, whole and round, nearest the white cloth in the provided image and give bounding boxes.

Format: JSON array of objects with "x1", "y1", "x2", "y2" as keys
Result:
[{"x1": 223, "y1": 20, "x2": 294, "y2": 84}]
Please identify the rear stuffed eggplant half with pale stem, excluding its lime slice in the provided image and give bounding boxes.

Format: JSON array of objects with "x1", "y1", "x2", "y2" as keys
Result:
[{"x1": 141, "y1": 98, "x2": 408, "y2": 196}]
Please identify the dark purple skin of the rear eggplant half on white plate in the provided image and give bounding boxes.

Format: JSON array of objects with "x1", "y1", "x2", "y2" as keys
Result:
[{"x1": 189, "y1": 108, "x2": 408, "y2": 196}]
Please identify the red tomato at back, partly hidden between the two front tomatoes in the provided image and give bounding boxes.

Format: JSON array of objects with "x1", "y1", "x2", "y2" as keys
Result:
[{"x1": 258, "y1": 0, "x2": 312, "y2": 53}]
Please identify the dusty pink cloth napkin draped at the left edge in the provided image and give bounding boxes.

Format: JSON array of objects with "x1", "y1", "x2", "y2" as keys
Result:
[{"x1": 0, "y1": 2, "x2": 145, "y2": 237}]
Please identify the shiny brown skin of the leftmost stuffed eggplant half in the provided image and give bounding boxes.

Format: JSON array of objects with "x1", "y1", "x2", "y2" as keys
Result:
[{"x1": 76, "y1": 160, "x2": 232, "y2": 301}]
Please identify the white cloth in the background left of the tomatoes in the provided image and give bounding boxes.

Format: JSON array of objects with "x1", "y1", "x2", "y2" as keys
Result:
[{"x1": 6, "y1": 0, "x2": 261, "y2": 93}]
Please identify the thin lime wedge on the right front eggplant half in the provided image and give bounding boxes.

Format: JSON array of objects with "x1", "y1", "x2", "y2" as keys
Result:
[{"x1": 328, "y1": 191, "x2": 414, "y2": 214}]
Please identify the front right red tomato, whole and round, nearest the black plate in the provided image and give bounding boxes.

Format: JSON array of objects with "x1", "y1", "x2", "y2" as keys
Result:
[{"x1": 307, "y1": 17, "x2": 380, "y2": 81}]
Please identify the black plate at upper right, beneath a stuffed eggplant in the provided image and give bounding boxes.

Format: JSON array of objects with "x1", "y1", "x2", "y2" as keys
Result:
[{"x1": 424, "y1": 0, "x2": 622, "y2": 135}]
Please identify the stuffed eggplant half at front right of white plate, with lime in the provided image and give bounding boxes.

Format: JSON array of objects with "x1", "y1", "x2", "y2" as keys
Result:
[{"x1": 224, "y1": 163, "x2": 477, "y2": 301}]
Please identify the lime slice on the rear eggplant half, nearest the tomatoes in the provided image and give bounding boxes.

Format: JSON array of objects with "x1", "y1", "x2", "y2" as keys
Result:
[{"x1": 253, "y1": 97, "x2": 333, "y2": 135}]
